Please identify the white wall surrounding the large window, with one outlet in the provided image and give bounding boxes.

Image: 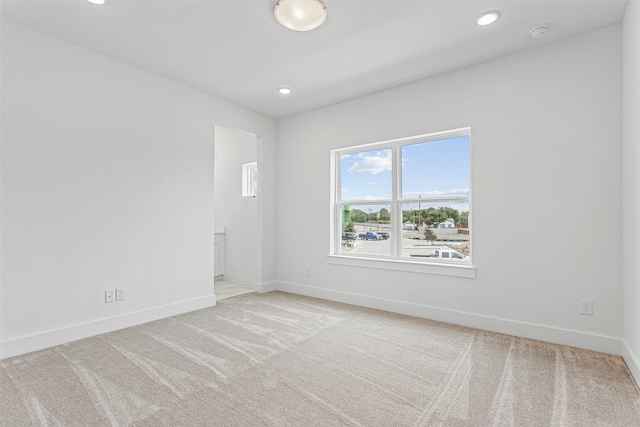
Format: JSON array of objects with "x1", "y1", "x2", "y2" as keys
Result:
[{"x1": 277, "y1": 25, "x2": 622, "y2": 353}]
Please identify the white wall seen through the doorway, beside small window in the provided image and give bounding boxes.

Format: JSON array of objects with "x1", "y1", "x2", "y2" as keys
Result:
[{"x1": 214, "y1": 127, "x2": 258, "y2": 285}]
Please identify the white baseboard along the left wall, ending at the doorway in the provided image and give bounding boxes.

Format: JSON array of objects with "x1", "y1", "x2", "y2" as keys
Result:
[{"x1": 0, "y1": 294, "x2": 216, "y2": 359}]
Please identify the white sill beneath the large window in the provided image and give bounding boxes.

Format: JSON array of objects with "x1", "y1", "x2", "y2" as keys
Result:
[{"x1": 327, "y1": 255, "x2": 476, "y2": 279}]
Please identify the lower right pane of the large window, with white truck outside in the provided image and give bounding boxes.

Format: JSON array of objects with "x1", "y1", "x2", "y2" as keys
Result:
[{"x1": 402, "y1": 201, "x2": 471, "y2": 262}]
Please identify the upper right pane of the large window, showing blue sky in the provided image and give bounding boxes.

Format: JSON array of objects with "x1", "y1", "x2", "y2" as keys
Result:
[{"x1": 402, "y1": 136, "x2": 470, "y2": 199}]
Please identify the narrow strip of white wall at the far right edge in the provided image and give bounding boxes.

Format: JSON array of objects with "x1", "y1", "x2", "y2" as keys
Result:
[{"x1": 622, "y1": 1, "x2": 640, "y2": 384}]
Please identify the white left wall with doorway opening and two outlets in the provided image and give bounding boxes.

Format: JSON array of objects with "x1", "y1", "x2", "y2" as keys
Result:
[{"x1": 0, "y1": 20, "x2": 276, "y2": 357}]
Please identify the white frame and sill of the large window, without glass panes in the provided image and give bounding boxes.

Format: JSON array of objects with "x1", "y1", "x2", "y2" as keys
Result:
[{"x1": 328, "y1": 127, "x2": 475, "y2": 278}]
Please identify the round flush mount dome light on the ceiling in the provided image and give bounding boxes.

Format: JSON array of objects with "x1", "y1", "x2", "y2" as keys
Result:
[{"x1": 273, "y1": 0, "x2": 327, "y2": 31}]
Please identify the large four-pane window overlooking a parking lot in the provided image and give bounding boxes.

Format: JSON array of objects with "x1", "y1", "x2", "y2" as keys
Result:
[{"x1": 331, "y1": 128, "x2": 471, "y2": 266}]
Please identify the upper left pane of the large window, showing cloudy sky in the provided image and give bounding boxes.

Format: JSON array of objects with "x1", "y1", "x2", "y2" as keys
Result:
[{"x1": 340, "y1": 148, "x2": 392, "y2": 201}]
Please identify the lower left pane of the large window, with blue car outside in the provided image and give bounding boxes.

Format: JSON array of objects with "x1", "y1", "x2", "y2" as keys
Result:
[{"x1": 340, "y1": 205, "x2": 391, "y2": 256}]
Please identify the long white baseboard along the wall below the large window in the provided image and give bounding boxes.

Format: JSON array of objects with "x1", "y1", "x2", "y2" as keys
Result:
[{"x1": 272, "y1": 282, "x2": 621, "y2": 356}]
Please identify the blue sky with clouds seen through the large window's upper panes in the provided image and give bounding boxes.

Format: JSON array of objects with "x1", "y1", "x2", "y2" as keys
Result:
[{"x1": 340, "y1": 136, "x2": 470, "y2": 209}]
